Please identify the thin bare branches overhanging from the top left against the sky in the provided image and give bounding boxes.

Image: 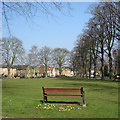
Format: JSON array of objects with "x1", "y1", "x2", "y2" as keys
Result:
[{"x1": 2, "y1": 1, "x2": 71, "y2": 34}]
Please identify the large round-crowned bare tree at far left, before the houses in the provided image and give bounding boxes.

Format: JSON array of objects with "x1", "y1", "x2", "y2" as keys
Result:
[{"x1": 2, "y1": 37, "x2": 24, "y2": 77}]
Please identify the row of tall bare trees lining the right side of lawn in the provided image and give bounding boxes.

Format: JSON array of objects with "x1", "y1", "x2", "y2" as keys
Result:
[{"x1": 72, "y1": 2, "x2": 120, "y2": 79}]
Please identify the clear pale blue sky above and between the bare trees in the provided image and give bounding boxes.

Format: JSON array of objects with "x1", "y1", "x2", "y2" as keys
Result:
[{"x1": 3, "y1": 2, "x2": 95, "y2": 51}]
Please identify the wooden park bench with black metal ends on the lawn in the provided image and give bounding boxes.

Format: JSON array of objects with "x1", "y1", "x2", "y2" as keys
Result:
[{"x1": 42, "y1": 87, "x2": 85, "y2": 105}]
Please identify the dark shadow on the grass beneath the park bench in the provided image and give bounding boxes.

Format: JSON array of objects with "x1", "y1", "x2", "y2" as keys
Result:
[{"x1": 40, "y1": 100, "x2": 81, "y2": 105}]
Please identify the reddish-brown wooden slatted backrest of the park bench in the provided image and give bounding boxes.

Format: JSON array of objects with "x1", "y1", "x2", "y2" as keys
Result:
[{"x1": 43, "y1": 87, "x2": 83, "y2": 95}]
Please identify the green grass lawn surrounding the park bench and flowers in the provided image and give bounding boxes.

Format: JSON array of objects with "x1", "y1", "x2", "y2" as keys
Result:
[{"x1": 2, "y1": 77, "x2": 118, "y2": 118}]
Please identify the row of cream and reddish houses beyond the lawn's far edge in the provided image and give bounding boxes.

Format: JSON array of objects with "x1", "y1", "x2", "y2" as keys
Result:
[{"x1": 0, "y1": 65, "x2": 73, "y2": 78}]
